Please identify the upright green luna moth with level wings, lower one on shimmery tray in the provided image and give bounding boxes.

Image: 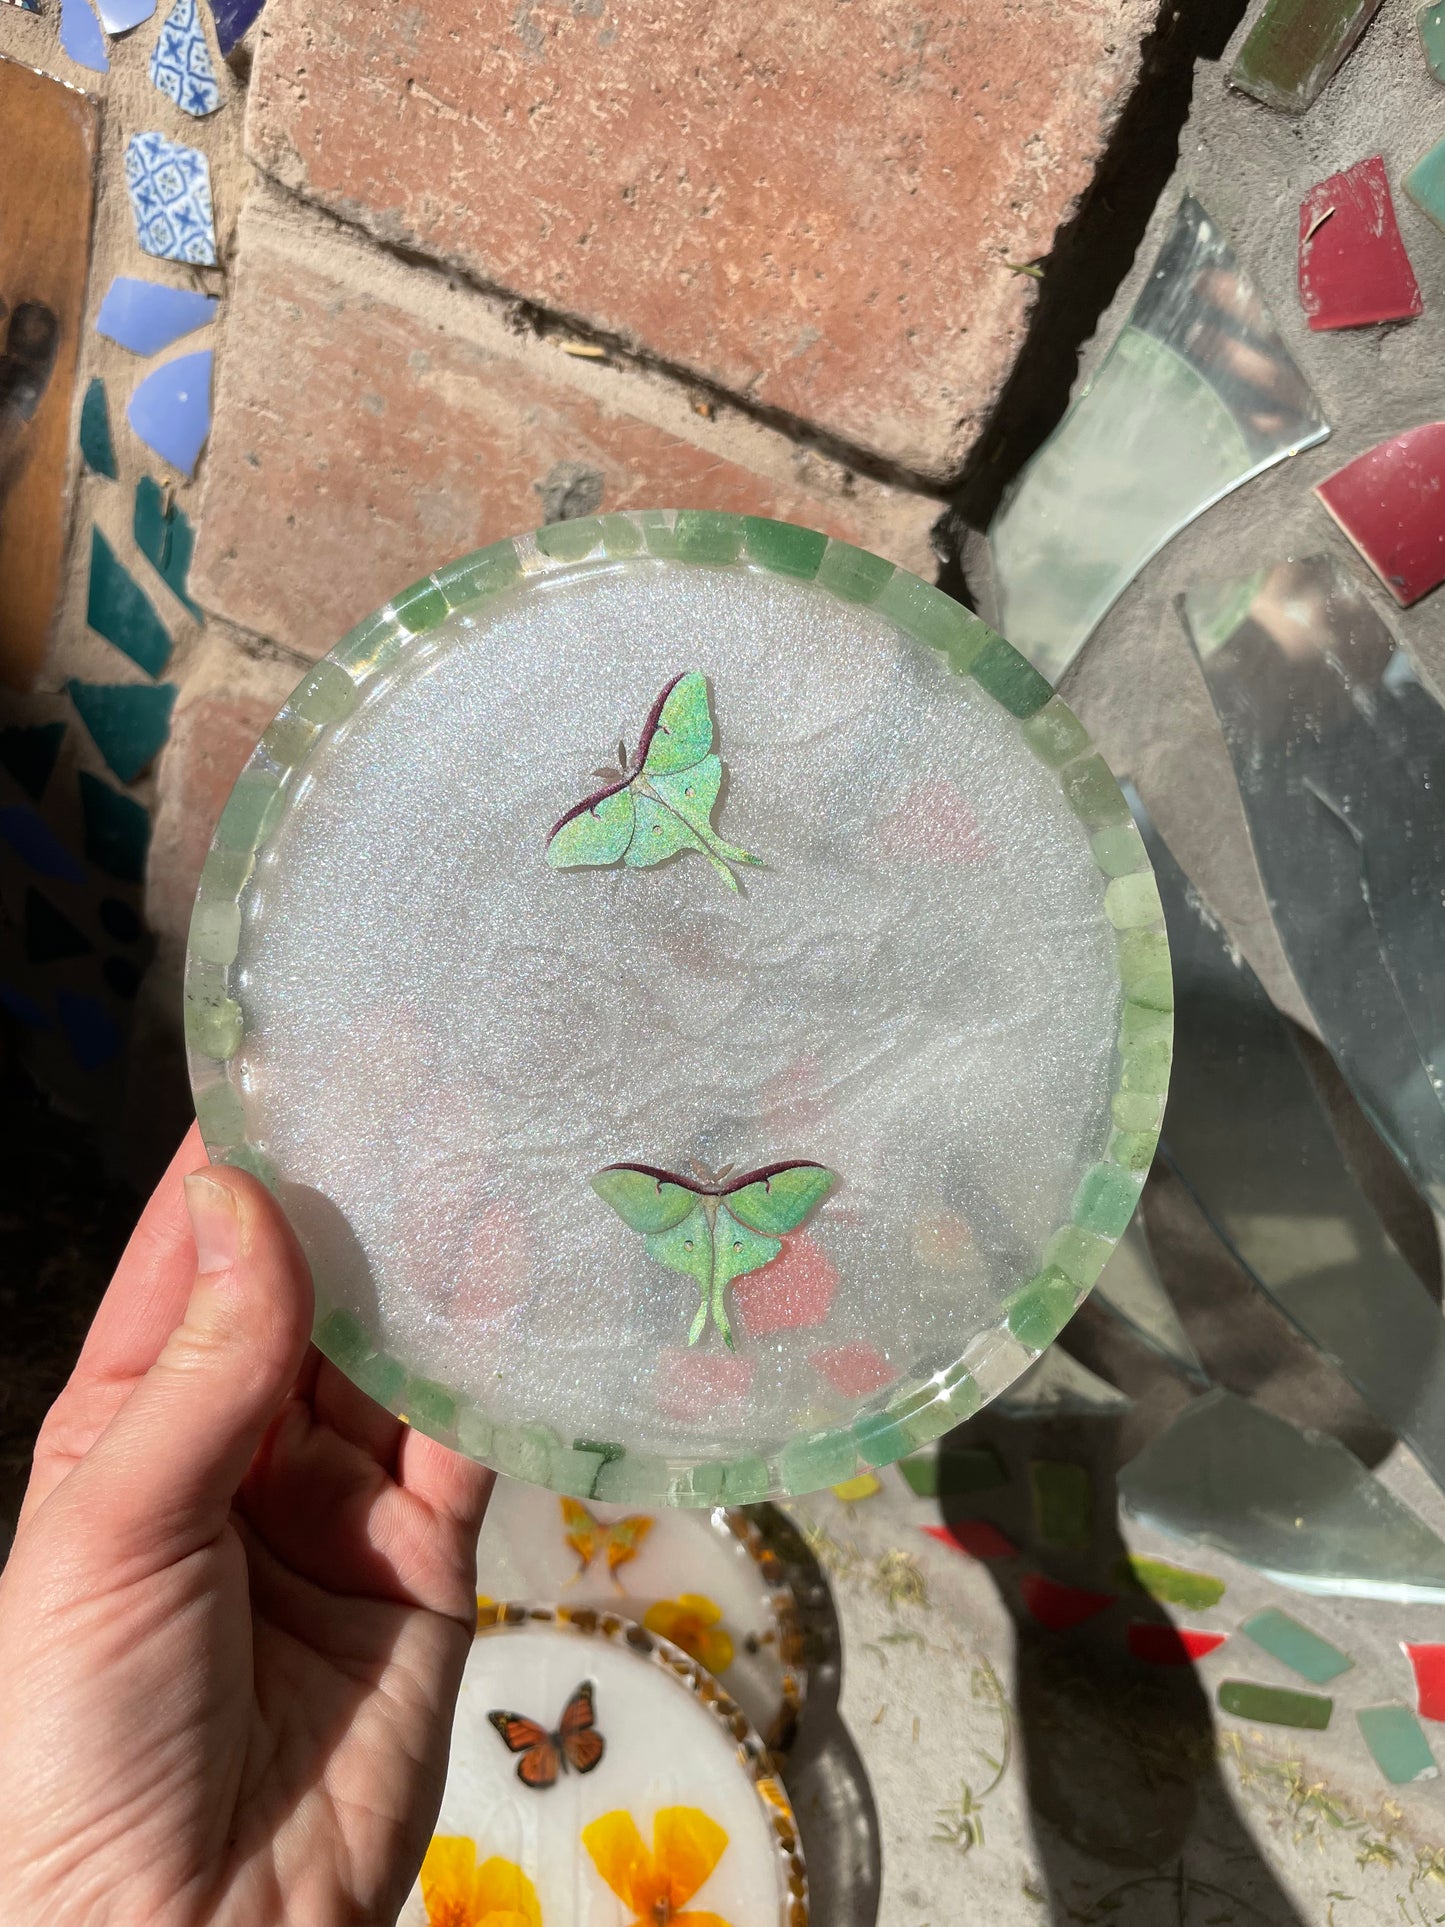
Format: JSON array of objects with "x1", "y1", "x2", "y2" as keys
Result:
[{"x1": 591, "y1": 1164, "x2": 838, "y2": 1351}]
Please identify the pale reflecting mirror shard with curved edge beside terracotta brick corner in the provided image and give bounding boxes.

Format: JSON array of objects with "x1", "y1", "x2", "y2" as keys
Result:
[{"x1": 988, "y1": 195, "x2": 1329, "y2": 682}]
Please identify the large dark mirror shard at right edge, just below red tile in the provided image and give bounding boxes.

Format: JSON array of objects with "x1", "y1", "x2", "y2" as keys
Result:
[{"x1": 1186, "y1": 555, "x2": 1445, "y2": 1210}]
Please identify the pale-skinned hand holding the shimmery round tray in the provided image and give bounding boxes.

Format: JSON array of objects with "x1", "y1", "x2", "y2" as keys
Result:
[{"x1": 0, "y1": 1133, "x2": 489, "y2": 1927}]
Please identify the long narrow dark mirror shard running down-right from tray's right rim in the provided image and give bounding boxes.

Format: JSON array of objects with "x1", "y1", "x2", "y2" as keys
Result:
[{"x1": 1139, "y1": 797, "x2": 1445, "y2": 1488}]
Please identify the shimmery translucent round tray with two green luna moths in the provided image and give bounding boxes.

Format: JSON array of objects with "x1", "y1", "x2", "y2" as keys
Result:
[{"x1": 185, "y1": 511, "x2": 1173, "y2": 1505}]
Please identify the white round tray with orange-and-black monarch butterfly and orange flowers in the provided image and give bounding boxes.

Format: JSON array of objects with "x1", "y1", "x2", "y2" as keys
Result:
[{"x1": 401, "y1": 1605, "x2": 807, "y2": 1927}]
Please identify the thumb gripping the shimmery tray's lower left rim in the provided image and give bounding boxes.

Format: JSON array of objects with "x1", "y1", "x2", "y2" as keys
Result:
[{"x1": 66, "y1": 1166, "x2": 312, "y2": 1563}]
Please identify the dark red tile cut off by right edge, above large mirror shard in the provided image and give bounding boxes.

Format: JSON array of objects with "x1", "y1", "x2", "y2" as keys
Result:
[{"x1": 1314, "y1": 422, "x2": 1445, "y2": 609}]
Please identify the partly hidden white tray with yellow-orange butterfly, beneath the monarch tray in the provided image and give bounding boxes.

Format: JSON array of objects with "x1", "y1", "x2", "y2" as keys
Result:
[{"x1": 476, "y1": 1478, "x2": 805, "y2": 1750}]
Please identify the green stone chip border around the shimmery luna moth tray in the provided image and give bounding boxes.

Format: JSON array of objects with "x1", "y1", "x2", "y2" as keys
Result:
[{"x1": 185, "y1": 509, "x2": 1173, "y2": 1507}]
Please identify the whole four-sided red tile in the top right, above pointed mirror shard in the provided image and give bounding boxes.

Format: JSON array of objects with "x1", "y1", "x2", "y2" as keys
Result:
[{"x1": 1299, "y1": 154, "x2": 1424, "y2": 330}]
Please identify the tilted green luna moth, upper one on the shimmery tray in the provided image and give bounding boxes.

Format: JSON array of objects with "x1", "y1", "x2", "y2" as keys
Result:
[{"x1": 547, "y1": 669, "x2": 761, "y2": 890}]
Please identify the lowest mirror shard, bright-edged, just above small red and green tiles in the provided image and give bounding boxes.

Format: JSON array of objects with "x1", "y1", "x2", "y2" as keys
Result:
[{"x1": 1119, "y1": 1391, "x2": 1445, "y2": 1605}]
